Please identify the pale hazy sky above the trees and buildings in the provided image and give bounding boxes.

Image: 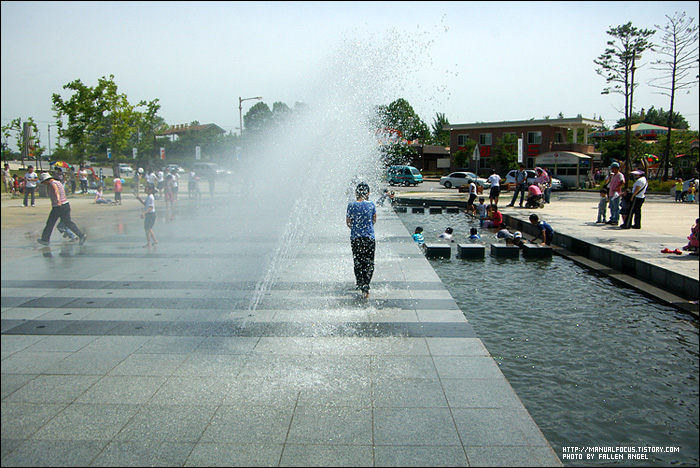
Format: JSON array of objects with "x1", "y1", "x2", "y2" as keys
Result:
[{"x1": 1, "y1": 1, "x2": 699, "y2": 150}]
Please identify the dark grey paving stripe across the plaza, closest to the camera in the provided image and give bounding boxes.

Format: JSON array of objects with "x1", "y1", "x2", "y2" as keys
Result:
[{"x1": 2, "y1": 320, "x2": 477, "y2": 338}]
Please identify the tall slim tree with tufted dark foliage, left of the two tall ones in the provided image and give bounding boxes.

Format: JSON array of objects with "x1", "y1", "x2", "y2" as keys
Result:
[{"x1": 594, "y1": 22, "x2": 655, "y2": 183}]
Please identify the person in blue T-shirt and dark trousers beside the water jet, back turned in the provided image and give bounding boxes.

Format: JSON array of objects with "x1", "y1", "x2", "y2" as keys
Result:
[{"x1": 345, "y1": 182, "x2": 377, "y2": 299}]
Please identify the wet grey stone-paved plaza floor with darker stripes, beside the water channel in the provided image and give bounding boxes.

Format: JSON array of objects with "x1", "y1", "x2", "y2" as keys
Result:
[{"x1": 1, "y1": 188, "x2": 561, "y2": 466}]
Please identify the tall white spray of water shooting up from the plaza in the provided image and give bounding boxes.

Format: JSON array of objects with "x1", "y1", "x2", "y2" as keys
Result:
[{"x1": 221, "y1": 27, "x2": 452, "y2": 311}]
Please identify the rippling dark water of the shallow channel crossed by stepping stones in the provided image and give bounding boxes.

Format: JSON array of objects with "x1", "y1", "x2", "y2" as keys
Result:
[{"x1": 399, "y1": 208, "x2": 699, "y2": 466}]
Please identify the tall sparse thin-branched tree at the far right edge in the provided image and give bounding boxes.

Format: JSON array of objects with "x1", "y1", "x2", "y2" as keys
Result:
[{"x1": 649, "y1": 12, "x2": 698, "y2": 180}]
